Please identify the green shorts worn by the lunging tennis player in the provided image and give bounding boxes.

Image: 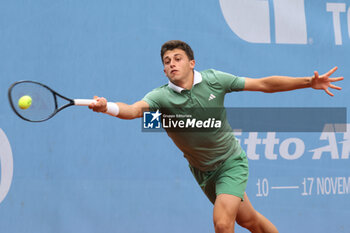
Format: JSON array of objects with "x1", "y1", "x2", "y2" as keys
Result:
[{"x1": 190, "y1": 150, "x2": 249, "y2": 204}]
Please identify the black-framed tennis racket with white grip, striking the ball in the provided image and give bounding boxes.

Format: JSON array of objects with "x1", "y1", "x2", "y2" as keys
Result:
[{"x1": 8, "y1": 81, "x2": 96, "y2": 122}]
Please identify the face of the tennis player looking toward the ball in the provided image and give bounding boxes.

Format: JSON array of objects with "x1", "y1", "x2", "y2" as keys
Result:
[{"x1": 163, "y1": 49, "x2": 195, "y2": 84}]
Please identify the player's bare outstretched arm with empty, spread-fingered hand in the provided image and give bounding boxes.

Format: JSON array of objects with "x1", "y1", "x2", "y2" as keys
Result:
[{"x1": 244, "y1": 67, "x2": 344, "y2": 96}]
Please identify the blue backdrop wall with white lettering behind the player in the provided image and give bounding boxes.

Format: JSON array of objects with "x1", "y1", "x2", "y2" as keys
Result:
[{"x1": 0, "y1": 0, "x2": 350, "y2": 233}]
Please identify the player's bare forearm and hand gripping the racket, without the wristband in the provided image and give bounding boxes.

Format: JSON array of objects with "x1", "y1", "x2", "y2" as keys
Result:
[{"x1": 89, "y1": 96, "x2": 149, "y2": 119}]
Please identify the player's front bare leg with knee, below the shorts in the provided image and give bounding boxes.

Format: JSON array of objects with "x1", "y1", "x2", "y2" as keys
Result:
[{"x1": 213, "y1": 194, "x2": 241, "y2": 233}]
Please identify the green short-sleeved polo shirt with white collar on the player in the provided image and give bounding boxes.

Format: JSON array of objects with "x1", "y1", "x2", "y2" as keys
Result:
[{"x1": 143, "y1": 69, "x2": 245, "y2": 171}]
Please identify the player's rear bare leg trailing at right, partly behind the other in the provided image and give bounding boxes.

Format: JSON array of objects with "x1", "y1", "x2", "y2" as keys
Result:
[{"x1": 236, "y1": 193, "x2": 278, "y2": 233}]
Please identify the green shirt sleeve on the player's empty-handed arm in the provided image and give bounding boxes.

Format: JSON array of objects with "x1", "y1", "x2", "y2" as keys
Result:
[{"x1": 214, "y1": 70, "x2": 245, "y2": 93}]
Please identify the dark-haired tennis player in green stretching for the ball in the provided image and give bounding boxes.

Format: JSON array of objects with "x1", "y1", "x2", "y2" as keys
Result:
[{"x1": 89, "y1": 40, "x2": 343, "y2": 233}]
